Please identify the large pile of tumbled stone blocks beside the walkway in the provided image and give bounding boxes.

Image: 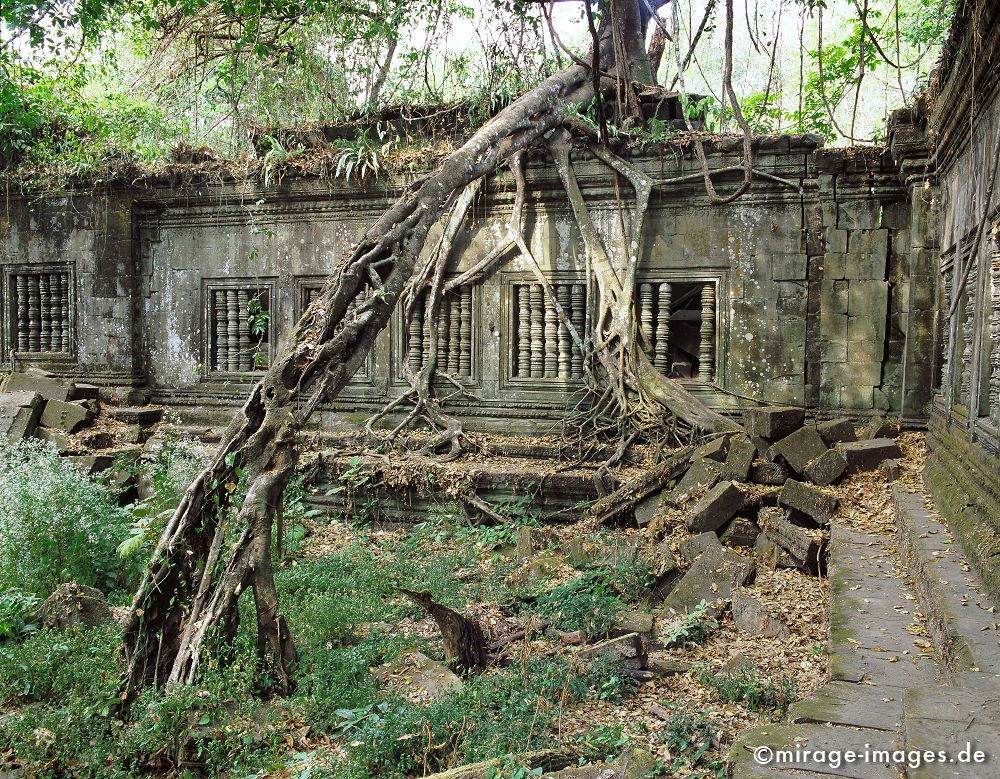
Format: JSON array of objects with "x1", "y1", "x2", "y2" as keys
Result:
[{"x1": 635, "y1": 407, "x2": 902, "y2": 580}]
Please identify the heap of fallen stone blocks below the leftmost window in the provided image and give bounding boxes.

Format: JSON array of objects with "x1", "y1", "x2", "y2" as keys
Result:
[{"x1": 0, "y1": 369, "x2": 163, "y2": 474}]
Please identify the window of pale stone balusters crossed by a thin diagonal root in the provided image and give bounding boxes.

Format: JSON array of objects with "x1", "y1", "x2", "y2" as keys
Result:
[{"x1": 511, "y1": 283, "x2": 587, "y2": 380}]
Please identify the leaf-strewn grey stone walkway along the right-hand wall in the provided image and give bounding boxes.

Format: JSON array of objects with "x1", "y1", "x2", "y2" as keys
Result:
[{"x1": 729, "y1": 478, "x2": 1000, "y2": 779}]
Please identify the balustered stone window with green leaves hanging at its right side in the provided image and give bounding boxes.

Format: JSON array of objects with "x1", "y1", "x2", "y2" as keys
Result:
[{"x1": 208, "y1": 285, "x2": 273, "y2": 373}]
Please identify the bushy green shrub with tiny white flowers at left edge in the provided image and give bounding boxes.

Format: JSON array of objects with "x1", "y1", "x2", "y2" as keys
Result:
[{"x1": 0, "y1": 441, "x2": 128, "y2": 597}]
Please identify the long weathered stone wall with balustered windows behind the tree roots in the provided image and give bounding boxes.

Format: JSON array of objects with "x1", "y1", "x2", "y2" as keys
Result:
[{"x1": 0, "y1": 135, "x2": 936, "y2": 432}]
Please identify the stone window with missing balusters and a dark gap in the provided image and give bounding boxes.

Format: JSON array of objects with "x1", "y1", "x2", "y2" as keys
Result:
[{"x1": 634, "y1": 281, "x2": 716, "y2": 382}]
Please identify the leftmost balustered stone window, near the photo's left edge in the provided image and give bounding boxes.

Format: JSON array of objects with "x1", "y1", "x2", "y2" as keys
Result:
[{"x1": 7, "y1": 266, "x2": 73, "y2": 354}]
